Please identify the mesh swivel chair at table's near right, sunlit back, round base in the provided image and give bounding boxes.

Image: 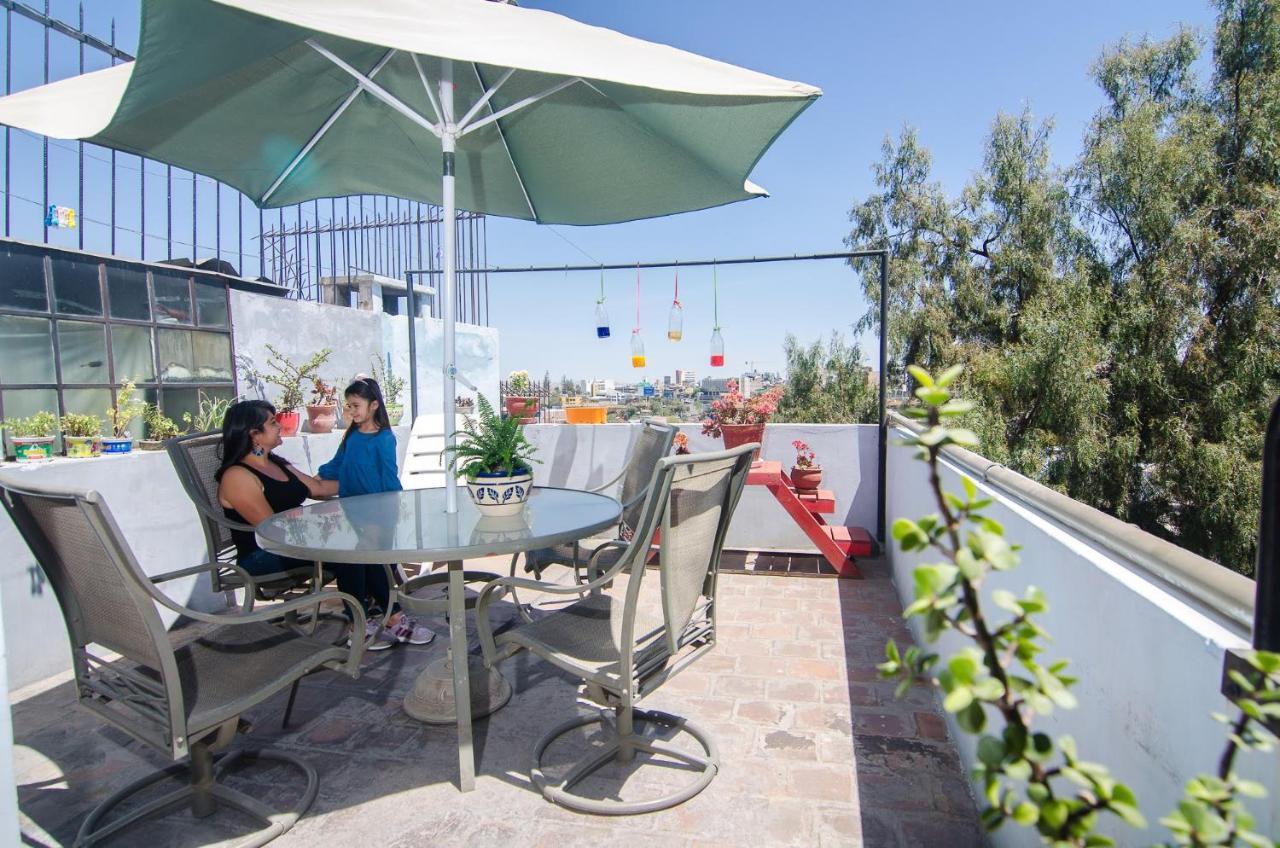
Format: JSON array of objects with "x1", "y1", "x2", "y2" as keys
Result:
[{"x1": 476, "y1": 444, "x2": 759, "y2": 815}]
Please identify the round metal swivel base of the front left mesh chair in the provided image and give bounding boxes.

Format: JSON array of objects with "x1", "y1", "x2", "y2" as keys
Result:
[{"x1": 76, "y1": 749, "x2": 320, "y2": 848}]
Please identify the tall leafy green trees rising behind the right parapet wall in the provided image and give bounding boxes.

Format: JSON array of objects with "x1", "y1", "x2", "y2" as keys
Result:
[{"x1": 847, "y1": 0, "x2": 1280, "y2": 574}]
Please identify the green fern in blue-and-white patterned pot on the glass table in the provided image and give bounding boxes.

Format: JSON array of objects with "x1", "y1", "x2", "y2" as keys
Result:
[{"x1": 448, "y1": 395, "x2": 539, "y2": 516}]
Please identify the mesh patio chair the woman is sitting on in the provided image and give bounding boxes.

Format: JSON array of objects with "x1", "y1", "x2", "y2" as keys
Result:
[{"x1": 165, "y1": 432, "x2": 324, "y2": 611}]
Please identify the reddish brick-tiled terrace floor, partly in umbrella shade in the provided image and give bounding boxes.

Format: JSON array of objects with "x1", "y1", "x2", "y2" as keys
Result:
[{"x1": 13, "y1": 557, "x2": 982, "y2": 848}]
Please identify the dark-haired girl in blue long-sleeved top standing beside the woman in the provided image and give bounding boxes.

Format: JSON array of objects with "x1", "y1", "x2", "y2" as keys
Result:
[{"x1": 316, "y1": 377, "x2": 435, "y2": 651}]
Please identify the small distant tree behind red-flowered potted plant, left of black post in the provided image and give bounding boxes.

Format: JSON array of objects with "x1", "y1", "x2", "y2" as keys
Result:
[{"x1": 773, "y1": 333, "x2": 878, "y2": 424}]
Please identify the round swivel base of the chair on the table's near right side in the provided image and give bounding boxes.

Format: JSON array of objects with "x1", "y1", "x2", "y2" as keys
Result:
[{"x1": 530, "y1": 710, "x2": 719, "y2": 816}]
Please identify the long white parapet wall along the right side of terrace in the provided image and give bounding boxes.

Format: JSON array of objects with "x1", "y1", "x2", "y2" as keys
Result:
[{"x1": 888, "y1": 430, "x2": 1280, "y2": 847}]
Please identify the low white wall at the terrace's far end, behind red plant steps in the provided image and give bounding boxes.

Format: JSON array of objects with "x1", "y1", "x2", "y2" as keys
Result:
[{"x1": 525, "y1": 424, "x2": 877, "y2": 552}]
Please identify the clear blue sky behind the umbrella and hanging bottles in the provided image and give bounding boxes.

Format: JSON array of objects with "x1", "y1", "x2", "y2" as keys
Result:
[{"x1": 7, "y1": 0, "x2": 1213, "y2": 380}]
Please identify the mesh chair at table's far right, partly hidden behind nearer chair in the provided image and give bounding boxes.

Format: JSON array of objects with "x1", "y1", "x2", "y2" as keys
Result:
[{"x1": 511, "y1": 419, "x2": 676, "y2": 583}]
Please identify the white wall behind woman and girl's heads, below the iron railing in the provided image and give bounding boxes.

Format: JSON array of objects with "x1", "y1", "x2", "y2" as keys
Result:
[{"x1": 230, "y1": 289, "x2": 498, "y2": 422}]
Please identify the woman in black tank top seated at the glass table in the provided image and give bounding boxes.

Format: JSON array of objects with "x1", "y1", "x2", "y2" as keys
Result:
[{"x1": 214, "y1": 401, "x2": 422, "y2": 651}]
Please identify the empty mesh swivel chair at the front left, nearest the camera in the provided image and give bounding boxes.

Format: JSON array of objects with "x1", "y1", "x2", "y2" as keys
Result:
[{"x1": 0, "y1": 479, "x2": 364, "y2": 845}]
